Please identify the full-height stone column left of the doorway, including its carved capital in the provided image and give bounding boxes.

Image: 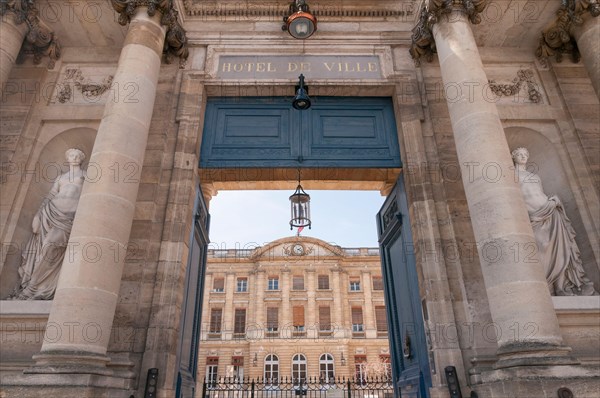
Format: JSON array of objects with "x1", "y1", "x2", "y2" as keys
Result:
[{"x1": 28, "y1": 0, "x2": 185, "y2": 374}]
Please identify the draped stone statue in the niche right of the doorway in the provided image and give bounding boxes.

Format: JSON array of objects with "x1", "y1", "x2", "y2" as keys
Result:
[{"x1": 512, "y1": 147, "x2": 598, "y2": 296}]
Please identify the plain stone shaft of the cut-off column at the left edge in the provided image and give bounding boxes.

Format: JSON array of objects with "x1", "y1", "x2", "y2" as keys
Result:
[{"x1": 0, "y1": 13, "x2": 29, "y2": 93}]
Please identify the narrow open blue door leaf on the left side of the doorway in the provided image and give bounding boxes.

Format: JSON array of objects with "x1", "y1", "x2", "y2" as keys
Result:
[{"x1": 176, "y1": 188, "x2": 210, "y2": 398}]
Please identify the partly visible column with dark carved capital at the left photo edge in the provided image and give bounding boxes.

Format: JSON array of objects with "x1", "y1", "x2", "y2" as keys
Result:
[{"x1": 0, "y1": 0, "x2": 60, "y2": 92}]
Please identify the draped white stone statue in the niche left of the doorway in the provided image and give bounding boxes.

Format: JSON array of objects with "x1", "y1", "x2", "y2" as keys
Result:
[{"x1": 9, "y1": 148, "x2": 85, "y2": 300}]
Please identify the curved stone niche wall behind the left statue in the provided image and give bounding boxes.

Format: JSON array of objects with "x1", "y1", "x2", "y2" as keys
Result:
[{"x1": 0, "y1": 128, "x2": 96, "y2": 300}]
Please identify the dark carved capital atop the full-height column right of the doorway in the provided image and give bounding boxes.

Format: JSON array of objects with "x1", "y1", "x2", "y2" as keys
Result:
[{"x1": 410, "y1": 0, "x2": 489, "y2": 65}]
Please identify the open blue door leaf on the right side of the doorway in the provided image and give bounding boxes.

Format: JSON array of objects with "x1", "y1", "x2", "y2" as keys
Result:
[{"x1": 377, "y1": 175, "x2": 431, "y2": 398}]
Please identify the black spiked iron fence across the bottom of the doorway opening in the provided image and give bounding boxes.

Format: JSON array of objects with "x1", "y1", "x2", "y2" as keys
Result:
[{"x1": 202, "y1": 377, "x2": 394, "y2": 398}]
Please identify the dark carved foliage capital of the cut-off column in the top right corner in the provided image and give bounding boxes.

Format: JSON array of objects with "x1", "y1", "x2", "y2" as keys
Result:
[{"x1": 535, "y1": 0, "x2": 600, "y2": 63}]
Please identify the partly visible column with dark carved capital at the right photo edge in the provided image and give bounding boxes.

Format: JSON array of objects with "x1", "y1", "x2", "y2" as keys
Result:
[{"x1": 536, "y1": 0, "x2": 600, "y2": 97}]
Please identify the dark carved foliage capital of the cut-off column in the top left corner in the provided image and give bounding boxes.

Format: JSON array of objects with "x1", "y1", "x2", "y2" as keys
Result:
[{"x1": 0, "y1": 0, "x2": 60, "y2": 69}]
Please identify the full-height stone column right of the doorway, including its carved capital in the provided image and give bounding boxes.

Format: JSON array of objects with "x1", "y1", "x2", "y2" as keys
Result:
[{"x1": 411, "y1": 0, "x2": 576, "y2": 368}]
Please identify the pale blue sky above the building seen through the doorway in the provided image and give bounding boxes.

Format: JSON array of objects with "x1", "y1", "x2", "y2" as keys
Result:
[{"x1": 209, "y1": 191, "x2": 384, "y2": 249}]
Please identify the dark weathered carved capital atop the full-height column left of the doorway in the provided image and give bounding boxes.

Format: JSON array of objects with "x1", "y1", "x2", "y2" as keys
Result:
[{"x1": 111, "y1": 0, "x2": 189, "y2": 68}]
